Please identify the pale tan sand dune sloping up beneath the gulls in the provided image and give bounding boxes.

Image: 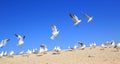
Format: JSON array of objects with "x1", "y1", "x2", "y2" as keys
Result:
[{"x1": 0, "y1": 47, "x2": 120, "y2": 64}]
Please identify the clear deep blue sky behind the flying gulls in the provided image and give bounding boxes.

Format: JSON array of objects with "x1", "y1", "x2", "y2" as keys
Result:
[{"x1": 0, "y1": 0, "x2": 120, "y2": 53}]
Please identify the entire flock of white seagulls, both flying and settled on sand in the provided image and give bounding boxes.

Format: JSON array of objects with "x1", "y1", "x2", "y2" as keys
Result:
[{"x1": 0, "y1": 13, "x2": 120, "y2": 58}]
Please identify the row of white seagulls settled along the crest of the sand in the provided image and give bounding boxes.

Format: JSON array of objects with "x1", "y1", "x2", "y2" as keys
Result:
[{"x1": 0, "y1": 40, "x2": 120, "y2": 58}]
